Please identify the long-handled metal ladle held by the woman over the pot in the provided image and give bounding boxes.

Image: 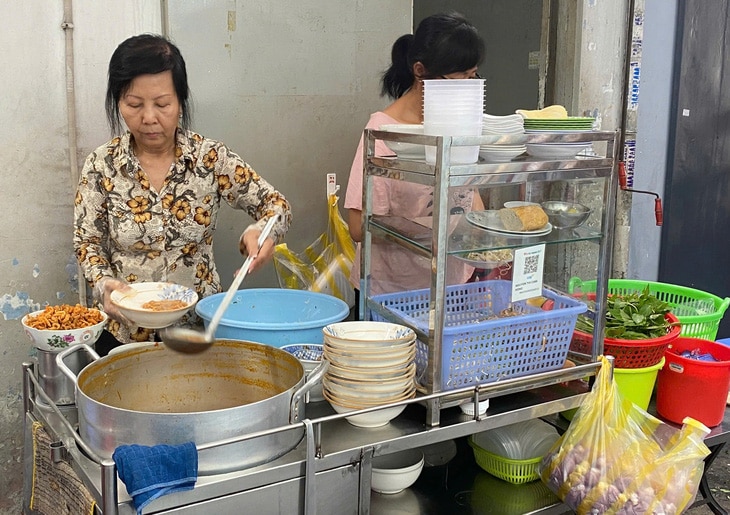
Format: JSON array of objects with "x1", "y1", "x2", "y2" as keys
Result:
[{"x1": 160, "y1": 215, "x2": 279, "y2": 354}]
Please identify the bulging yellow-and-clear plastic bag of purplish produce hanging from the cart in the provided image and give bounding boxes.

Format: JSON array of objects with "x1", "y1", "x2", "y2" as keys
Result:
[{"x1": 538, "y1": 357, "x2": 710, "y2": 515}]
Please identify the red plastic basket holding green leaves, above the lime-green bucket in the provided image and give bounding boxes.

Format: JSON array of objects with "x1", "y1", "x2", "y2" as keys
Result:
[{"x1": 570, "y1": 313, "x2": 682, "y2": 368}]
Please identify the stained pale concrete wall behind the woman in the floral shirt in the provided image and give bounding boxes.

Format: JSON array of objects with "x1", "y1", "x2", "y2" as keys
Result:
[{"x1": 0, "y1": 0, "x2": 411, "y2": 514}]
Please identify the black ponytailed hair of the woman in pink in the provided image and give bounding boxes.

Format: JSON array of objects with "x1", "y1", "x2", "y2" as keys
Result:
[{"x1": 381, "y1": 12, "x2": 484, "y2": 99}]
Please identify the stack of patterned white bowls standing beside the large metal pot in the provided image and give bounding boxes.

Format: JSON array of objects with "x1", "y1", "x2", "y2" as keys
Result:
[{"x1": 322, "y1": 322, "x2": 416, "y2": 427}]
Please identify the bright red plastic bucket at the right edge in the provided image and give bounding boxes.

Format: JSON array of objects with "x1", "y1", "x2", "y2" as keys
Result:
[{"x1": 656, "y1": 337, "x2": 730, "y2": 427}]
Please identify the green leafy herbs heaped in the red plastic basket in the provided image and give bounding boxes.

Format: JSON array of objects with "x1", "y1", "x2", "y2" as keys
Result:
[{"x1": 575, "y1": 285, "x2": 672, "y2": 340}]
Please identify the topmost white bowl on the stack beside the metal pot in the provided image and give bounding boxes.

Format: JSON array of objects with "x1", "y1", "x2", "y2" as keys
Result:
[{"x1": 322, "y1": 321, "x2": 416, "y2": 349}]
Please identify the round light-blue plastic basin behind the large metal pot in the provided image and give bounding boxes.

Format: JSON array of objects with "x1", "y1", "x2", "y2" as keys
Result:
[{"x1": 195, "y1": 288, "x2": 350, "y2": 347}]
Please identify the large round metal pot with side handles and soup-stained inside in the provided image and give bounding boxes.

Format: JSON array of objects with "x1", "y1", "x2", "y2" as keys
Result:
[{"x1": 57, "y1": 340, "x2": 326, "y2": 474}]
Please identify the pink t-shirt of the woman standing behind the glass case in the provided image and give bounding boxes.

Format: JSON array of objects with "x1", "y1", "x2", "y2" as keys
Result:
[{"x1": 344, "y1": 111, "x2": 474, "y2": 295}]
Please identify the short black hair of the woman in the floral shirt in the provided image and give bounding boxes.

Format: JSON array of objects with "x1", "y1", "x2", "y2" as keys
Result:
[{"x1": 105, "y1": 34, "x2": 191, "y2": 135}]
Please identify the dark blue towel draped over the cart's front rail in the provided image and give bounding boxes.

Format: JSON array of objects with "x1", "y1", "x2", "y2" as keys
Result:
[{"x1": 112, "y1": 442, "x2": 198, "y2": 515}]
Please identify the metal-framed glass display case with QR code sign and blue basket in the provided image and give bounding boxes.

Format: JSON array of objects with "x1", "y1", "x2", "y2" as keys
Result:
[{"x1": 359, "y1": 130, "x2": 618, "y2": 425}]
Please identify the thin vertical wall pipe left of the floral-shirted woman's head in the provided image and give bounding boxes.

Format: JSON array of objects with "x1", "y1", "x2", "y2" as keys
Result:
[{"x1": 61, "y1": 0, "x2": 86, "y2": 306}]
